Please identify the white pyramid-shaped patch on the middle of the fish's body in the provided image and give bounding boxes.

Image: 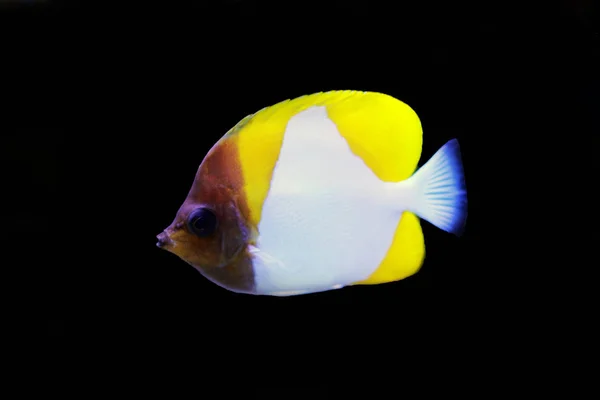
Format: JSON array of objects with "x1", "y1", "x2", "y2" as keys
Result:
[{"x1": 253, "y1": 107, "x2": 403, "y2": 296}]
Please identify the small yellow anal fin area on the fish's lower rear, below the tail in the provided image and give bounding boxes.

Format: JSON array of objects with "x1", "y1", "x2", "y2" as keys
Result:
[{"x1": 354, "y1": 211, "x2": 425, "y2": 285}]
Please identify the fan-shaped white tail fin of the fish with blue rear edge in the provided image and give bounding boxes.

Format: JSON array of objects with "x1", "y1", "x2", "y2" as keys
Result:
[{"x1": 409, "y1": 139, "x2": 467, "y2": 236}]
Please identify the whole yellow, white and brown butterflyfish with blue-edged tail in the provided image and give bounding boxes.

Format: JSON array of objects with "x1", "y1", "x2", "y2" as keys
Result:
[{"x1": 156, "y1": 90, "x2": 467, "y2": 296}]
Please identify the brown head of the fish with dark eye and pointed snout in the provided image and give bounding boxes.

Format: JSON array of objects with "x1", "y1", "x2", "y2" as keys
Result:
[{"x1": 157, "y1": 136, "x2": 255, "y2": 293}]
